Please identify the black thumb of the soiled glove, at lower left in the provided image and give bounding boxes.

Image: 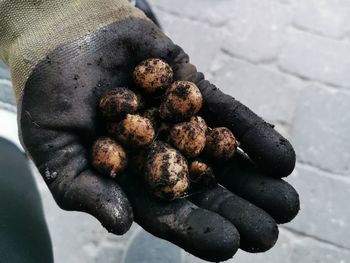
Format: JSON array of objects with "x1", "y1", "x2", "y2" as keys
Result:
[{"x1": 51, "y1": 170, "x2": 134, "y2": 235}]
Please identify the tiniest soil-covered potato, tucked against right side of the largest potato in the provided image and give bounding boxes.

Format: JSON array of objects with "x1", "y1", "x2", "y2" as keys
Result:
[{"x1": 189, "y1": 159, "x2": 217, "y2": 187}]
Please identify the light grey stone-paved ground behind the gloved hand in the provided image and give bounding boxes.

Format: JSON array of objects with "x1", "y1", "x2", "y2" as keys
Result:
[{"x1": 0, "y1": 0, "x2": 350, "y2": 263}]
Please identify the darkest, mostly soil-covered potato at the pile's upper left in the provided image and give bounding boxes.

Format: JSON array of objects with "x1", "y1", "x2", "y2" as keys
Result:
[{"x1": 99, "y1": 88, "x2": 139, "y2": 121}]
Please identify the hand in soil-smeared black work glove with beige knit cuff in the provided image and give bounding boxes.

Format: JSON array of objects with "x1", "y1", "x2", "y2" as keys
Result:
[{"x1": 0, "y1": 0, "x2": 299, "y2": 261}]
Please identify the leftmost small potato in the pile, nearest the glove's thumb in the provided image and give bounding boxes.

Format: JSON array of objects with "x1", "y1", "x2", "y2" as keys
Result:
[{"x1": 92, "y1": 137, "x2": 127, "y2": 178}]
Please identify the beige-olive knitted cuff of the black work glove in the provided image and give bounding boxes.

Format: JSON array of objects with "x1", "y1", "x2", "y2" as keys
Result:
[{"x1": 0, "y1": 0, "x2": 147, "y2": 101}]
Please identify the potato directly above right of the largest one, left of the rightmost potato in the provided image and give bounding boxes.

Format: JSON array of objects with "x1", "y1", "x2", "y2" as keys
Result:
[{"x1": 170, "y1": 122, "x2": 206, "y2": 158}]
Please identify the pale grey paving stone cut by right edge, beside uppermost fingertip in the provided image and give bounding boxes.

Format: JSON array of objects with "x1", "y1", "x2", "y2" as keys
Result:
[{"x1": 291, "y1": 85, "x2": 350, "y2": 176}]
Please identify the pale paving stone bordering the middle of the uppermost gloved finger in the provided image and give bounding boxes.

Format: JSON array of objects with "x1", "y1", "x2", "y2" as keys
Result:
[{"x1": 213, "y1": 57, "x2": 303, "y2": 129}]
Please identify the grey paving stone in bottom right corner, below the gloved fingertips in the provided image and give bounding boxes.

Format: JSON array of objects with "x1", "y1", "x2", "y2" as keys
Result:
[{"x1": 185, "y1": 229, "x2": 350, "y2": 263}]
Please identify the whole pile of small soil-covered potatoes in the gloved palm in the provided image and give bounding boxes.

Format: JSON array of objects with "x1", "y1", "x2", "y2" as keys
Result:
[{"x1": 92, "y1": 58, "x2": 238, "y2": 200}]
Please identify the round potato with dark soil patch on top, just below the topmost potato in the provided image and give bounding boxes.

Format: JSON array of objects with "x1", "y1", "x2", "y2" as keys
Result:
[{"x1": 160, "y1": 81, "x2": 203, "y2": 122}]
